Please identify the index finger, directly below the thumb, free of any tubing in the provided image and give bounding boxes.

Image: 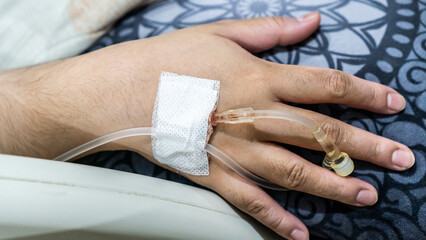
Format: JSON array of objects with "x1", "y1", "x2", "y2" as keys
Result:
[{"x1": 268, "y1": 64, "x2": 405, "y2": 114}]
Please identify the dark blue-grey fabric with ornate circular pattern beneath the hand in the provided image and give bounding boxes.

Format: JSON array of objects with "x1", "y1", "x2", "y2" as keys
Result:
[{"x1": 80, "y1": 0, "x2": 426, "y2": 240}]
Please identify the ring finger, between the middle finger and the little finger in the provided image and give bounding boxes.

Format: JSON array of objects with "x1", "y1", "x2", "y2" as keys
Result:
[{"x1": 213, "y1": 142, "x2": 377, "y2": 206}]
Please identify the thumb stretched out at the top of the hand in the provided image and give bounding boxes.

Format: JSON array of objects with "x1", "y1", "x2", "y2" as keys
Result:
[{"x1": 206, "y1": 11, "x2": 321, "y2": 52}]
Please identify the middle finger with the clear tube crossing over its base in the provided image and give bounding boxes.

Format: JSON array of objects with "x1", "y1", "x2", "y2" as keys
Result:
[{"x1": 254, "y1": 103, "x2": 414, "y2": 171}]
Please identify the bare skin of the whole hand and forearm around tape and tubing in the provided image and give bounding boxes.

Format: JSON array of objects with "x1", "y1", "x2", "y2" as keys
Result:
[{"x1": 0, "y1": 12, "x2": 414, "y2": 239}]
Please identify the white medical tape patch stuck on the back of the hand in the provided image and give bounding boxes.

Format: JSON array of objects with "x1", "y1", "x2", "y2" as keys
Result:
[{"x1": 151, "y1": 72, "x2": 220, "y2": 175}]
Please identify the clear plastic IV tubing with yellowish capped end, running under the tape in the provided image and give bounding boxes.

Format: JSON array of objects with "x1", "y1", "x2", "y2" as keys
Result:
[{"x1": 54, "y1": 108, "x2": 354, "y2": 191}]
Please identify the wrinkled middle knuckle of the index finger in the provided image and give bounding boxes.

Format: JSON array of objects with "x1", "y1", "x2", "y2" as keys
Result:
[{"x1": 324, "y1": 70, "x2": 352, "y2": 98}]
